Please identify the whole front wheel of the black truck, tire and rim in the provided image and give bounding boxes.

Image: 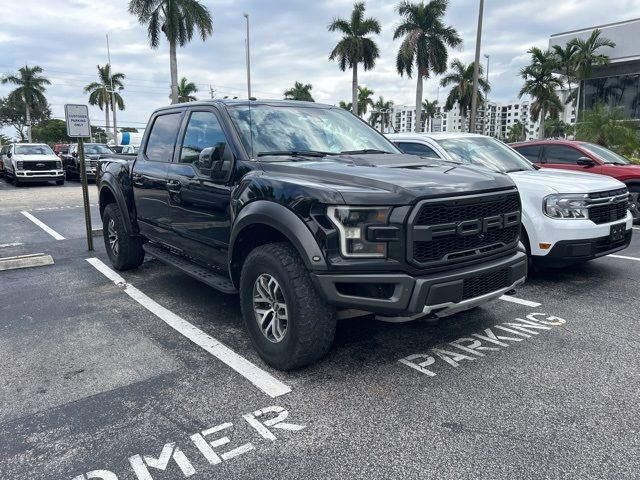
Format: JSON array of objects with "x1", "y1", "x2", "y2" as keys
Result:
[{"x1": 240, "y1": 243, "x2": 336, "y2": 370}]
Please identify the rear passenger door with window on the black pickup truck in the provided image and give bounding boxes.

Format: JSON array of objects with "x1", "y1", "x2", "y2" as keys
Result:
[{"x1": 131, "y1": 112, "x2": 182, "y2": 241}]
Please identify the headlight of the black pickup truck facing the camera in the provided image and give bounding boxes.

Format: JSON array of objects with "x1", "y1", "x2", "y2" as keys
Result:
[{"x1": 327, "y1": 206, "x2": 391, "y2": 258}]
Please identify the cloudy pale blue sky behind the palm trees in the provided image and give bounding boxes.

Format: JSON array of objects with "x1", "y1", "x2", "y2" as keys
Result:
[{"x1": 0, "y1": 0, "x2": 640, "y2": 135}]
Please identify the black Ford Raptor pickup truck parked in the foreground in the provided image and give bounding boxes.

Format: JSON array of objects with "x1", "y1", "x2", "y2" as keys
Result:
[{"x1": 97, "y1": 99, "x2": 527, "y2": 369}]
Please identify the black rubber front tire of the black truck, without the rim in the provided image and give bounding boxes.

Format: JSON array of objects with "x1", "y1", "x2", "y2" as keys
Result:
[{"x1": 240, "y1": 243, "x2": 336, "y2": 370}]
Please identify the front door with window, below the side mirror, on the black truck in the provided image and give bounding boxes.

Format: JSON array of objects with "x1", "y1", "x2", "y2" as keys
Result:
[{"x1": 167, "y1": 110, "x2": 231, "y2": 267}]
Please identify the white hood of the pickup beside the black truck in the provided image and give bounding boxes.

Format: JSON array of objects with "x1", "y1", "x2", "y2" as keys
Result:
[{"x1": 508, "y1": 168, "x2": 624, "y2": 195}]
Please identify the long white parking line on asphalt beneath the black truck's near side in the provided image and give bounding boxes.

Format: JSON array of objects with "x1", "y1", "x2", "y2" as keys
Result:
[{"x1": 87, "y1": 258, "x2": 291, "y2": 398}]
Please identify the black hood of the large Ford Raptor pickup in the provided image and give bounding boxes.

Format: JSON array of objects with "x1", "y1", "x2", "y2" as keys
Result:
[{"x1": 260, "y1": 154, "x2": 513, "y2": 205}]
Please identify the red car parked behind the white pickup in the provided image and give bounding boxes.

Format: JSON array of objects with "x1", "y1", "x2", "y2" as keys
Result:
[{"x1": 511, "y1": 140, "x2": 640, "y2": 223}]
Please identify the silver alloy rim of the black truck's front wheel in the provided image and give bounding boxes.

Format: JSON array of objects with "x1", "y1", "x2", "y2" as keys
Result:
[{"x1": 253, "y1": 273, "x2": 289, "y2": 343}]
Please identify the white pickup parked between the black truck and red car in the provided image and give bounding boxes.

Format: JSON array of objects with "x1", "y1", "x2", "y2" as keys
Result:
[{"x1": 388, "y1": 133, "x2": 633, "y2": 267}]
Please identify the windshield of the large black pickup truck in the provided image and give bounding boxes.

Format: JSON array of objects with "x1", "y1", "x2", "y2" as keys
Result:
[{"x1": 229, "y1": 105, "x2": 399, "y2": 157}]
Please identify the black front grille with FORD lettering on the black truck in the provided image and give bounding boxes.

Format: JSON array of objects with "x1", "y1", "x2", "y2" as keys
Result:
[{"x1": 407, "y1": 190, "x2": 521, "y2": 267}]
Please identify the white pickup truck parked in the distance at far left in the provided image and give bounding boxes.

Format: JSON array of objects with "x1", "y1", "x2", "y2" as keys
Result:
[{"x1": 2, "y1": 143, "x2": 64, "y2": 187}]
